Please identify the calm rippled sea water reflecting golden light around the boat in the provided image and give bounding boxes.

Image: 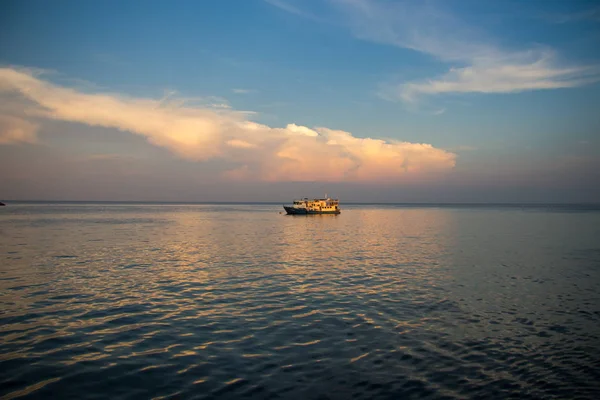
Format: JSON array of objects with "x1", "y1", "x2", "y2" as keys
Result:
[{"x1": 0, "y1": 204, "x2": 600, "y2": 399}]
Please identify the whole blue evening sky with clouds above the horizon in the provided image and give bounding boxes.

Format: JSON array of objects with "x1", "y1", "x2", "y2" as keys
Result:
[{"x1": 0, "y1": 0, "x2": 600, "y2": 200}]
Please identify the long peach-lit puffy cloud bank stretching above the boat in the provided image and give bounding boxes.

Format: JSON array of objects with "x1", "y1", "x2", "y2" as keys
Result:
[{"x1": 0, "y1": 68, "x2": 456, "y2": 182}]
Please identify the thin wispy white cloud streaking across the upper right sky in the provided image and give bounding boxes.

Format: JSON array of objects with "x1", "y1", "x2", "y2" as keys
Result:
[{"x1": 270, "y1": 0, "x2": 600, "y2": 103}]
